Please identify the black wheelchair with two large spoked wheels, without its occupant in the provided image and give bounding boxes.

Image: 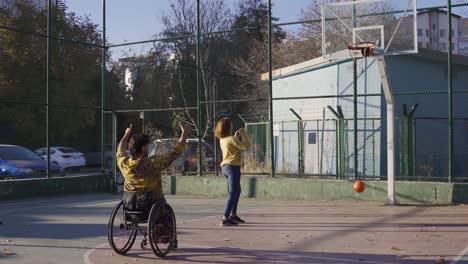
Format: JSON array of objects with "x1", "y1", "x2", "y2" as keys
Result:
[{"x1": 107, "y1": 199, "x2": 177, "y2": 258}]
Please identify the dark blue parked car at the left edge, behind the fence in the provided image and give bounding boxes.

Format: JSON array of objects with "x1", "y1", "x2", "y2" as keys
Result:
[{"x1": 0, "y1": 145, "x2": 62, "y2": 179}]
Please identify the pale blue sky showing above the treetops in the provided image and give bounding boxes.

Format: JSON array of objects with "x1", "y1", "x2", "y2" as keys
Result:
[{"x1": 63, "y1": 0, "x2": 468, "y2": 59}]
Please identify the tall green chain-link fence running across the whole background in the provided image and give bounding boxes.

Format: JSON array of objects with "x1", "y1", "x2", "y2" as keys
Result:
[{"x1": 0, "y1": 0, "x2": 468, "y2": 186}]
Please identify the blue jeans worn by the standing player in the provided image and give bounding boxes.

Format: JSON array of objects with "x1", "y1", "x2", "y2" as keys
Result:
[{"x1": 223, "y1": 164, "x2": 241, "y2": 217}]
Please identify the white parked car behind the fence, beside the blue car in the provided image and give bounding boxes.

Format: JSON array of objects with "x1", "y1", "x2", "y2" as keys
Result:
[{"x1": 34, "y1": 147, "x2": 86, "y2": 170}]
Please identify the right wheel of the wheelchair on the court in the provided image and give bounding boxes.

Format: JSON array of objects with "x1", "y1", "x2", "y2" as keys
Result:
[{"x1": 148, "y1": 202, "x2": 177, "y2": 258}]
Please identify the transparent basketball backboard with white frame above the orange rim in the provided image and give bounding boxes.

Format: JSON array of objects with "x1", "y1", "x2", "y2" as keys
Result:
[{"x1": 322, "y1": 0, "x2": 418, "y2": 59}]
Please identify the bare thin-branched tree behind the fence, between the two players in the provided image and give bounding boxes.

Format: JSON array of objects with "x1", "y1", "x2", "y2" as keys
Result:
[{"x1": 162, "y1": 0, "x2": 232, "y2": 138}]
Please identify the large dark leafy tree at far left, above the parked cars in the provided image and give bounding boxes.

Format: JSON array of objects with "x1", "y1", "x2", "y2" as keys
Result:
[{"x1": 0, "y1": 0, "x2": 110, "y2": 149}]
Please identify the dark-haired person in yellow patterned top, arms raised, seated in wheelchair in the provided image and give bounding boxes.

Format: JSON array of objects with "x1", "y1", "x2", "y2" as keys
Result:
[{"x1": 117, "y1": 125, "x2": 192, "y2": 243}]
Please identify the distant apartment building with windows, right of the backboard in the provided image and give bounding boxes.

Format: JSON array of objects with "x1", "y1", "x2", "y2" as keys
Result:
[{"x1": 417, "y1": 9, "x2": 468, "y2": 54}]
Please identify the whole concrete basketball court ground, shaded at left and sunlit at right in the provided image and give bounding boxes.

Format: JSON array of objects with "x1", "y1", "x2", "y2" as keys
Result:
[{"x1": 0, "y1": 194, "x2": 468, "y2": 264}]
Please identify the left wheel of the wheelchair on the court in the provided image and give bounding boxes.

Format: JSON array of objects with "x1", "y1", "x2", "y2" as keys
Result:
[{"x1": 107, "y1": 201, "x2": 138, "y2": 255}]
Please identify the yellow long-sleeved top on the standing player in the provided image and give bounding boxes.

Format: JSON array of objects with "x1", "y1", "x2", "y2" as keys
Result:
[{"x1": 219, "y1": 136, "x2": 250, "y2": 167}]
